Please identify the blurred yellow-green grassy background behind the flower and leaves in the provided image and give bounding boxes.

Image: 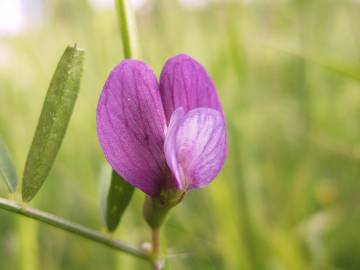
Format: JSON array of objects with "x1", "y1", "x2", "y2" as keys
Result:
[{"x1": 0, "y1": 0, "x2": 360, "y2": 270}]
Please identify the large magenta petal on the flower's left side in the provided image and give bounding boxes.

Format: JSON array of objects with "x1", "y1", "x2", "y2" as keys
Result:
[{"x1": 96, "y1": 60, "x2": 167, "y2": 195}]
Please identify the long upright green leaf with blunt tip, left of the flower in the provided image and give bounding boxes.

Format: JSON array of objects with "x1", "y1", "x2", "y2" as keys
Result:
[{"x1": 22, "y1": 45, "x2": 84, "y2": 201}]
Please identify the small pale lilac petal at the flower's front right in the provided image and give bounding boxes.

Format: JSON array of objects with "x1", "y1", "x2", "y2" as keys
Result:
[{"x1": 164, "y1": 108, "x2": 227, "y2": 190}]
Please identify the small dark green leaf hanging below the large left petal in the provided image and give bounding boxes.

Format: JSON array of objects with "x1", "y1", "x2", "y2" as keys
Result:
[{"x1": 100, "y1": 168, "x2": 134, "y2": 232}]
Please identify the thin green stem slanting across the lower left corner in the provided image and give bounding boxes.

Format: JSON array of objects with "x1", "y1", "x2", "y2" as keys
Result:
[{"x1": 0, "y1": 198, "x2": 151, "y2": 261}]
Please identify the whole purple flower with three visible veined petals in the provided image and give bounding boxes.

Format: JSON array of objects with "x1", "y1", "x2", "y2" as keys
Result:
[{"x1": 96, "y1": 55, "x2": 227, "y2": 196}]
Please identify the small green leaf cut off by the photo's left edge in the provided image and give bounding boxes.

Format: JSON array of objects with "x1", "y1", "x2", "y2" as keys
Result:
[{"x1": 0, "y1": 138, "x2": 18, "y2": 193}]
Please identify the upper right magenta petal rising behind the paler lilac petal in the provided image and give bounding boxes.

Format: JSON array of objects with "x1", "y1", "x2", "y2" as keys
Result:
[{"x1": 160, "y1": 54, "x2": 223, "y2": 122}]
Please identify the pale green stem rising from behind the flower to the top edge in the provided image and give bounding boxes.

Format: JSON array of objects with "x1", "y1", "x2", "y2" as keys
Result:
[{"x1": 115, "y1": 0, "x2": 139, "y2": 58}]
